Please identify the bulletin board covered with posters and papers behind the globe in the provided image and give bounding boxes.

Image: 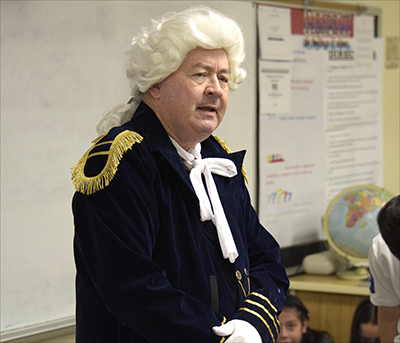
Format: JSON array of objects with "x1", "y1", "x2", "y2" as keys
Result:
[{"x1": 257, "y1": 4, "x2": 383, "y2": 248}]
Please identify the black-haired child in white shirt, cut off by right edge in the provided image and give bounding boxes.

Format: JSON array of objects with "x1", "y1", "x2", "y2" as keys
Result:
[{"x1": 369, "y1": 195, "x2": 400, "y2": 343}]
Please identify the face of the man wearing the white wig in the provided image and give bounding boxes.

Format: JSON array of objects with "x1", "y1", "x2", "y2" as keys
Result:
[{"x1": 149, "y1": 48, "x2": 230, "y2": 150}]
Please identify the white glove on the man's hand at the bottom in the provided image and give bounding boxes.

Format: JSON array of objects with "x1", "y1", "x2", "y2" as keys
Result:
[{"x1": 213, "y1": 319, "x2": 262, "y2": 343}]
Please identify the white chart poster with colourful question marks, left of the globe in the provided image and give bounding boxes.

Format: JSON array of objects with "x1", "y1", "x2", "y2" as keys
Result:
[{"x1": 259, "y1": 37, "x2": 325, "y2": 249}]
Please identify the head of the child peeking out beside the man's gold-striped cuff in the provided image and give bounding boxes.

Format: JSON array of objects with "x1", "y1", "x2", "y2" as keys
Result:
[{"x1": 277, "y1": 294, "x2": 308, "y2": 343}]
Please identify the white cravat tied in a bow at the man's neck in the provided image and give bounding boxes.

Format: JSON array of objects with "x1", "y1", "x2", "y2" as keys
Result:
[{"x1": 170, "y1": 137, "x2": 239, "y2": 263}]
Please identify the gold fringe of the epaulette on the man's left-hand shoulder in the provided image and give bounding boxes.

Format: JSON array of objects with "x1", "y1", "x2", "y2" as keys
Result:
[{"x1": 71, "y1": 130, "x2": 143, "y2": 195}]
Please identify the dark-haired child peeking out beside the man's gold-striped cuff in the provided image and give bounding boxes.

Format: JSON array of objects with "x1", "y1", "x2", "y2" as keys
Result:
[{"x1": 277, "y1": 294, "x2": 333, "y2": 343}]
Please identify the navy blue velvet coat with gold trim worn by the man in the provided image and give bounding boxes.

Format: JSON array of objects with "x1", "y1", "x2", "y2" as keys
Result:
[{"x1": 73, "y1": 103, "x2": 288, "y2": 343}]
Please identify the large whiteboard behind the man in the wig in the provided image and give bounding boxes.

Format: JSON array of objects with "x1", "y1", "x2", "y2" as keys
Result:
[{"x1": 0, "y1": 1, "x2": 257, "y2": 333}]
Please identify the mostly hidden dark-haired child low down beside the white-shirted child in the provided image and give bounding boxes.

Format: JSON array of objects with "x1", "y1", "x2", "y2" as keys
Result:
[{"x1": 350, "y1": 298, "x2": 380, "y2": 343}]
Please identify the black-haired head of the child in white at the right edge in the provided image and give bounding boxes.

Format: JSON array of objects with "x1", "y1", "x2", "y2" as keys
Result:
[{"x1": 377, "y1": 195, "x2": 400, "y2": 260}]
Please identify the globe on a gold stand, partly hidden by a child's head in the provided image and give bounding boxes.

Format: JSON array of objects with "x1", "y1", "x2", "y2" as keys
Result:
[{"x1": 322, "y1": 185, "x2": 393, "y2": 279}]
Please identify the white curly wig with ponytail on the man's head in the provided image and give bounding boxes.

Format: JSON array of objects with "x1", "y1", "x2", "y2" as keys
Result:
[{"x1": 97, "y1": 6, "x2": 246, "y2": 134}]
